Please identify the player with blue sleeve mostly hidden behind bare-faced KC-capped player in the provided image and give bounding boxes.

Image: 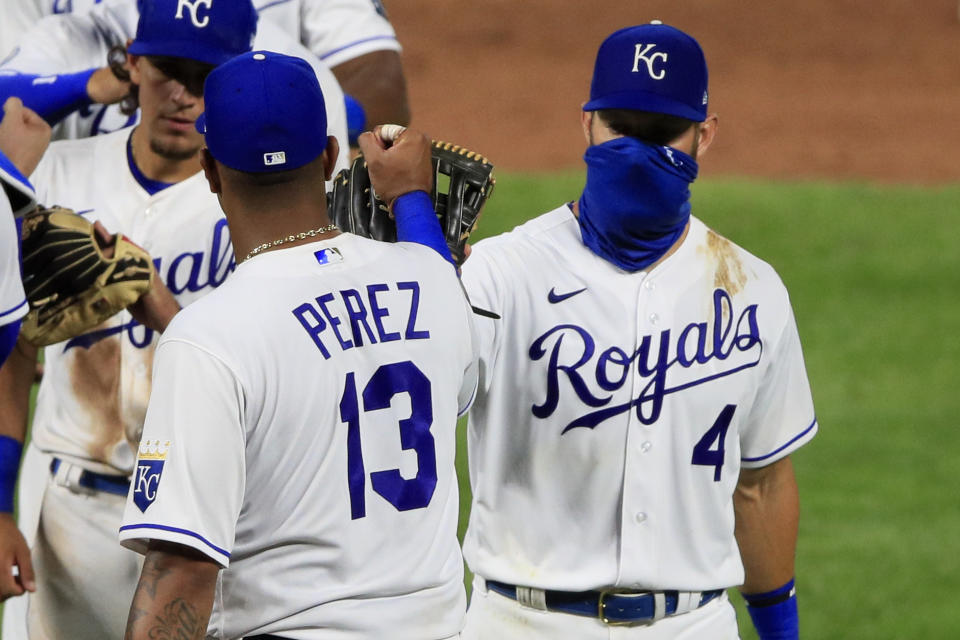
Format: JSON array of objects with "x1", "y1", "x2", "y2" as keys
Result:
[{"x1": 0, "y1": 0, "x2": 348, "y2": 150}]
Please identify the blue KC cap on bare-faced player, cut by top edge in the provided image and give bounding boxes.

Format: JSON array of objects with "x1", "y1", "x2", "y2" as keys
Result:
[{"x1": 127, "y1": 0, "x2": 257, "y2": 65}]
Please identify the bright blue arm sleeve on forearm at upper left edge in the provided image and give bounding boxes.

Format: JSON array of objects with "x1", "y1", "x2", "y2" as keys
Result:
[{"x1": 0, "y1": 69, "x2": 96, "y2": 125}]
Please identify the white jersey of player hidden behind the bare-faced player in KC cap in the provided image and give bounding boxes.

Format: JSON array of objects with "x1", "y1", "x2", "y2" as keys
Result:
[{"x1": 0, "y1": 0, "x2": 349, "y2": 171}]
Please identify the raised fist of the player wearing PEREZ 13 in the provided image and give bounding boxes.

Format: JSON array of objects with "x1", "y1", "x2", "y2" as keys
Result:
[{"x1": 357, "y1": 127, "x2": 433, "y2": 207}]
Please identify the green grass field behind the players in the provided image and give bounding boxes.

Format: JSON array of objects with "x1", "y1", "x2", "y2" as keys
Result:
[{"x1": 3, "y1": 173, "x2": 960, "y2": 640}]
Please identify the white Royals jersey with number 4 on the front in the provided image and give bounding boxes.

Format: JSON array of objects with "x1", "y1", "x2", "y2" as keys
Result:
[{"x1": 463, "y1": 206, "x2": 817, "y2": 591}]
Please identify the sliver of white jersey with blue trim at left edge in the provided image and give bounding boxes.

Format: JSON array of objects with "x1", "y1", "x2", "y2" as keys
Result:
[{"x1": 0, "y1": 154, "x2": 36, "y2": 325}]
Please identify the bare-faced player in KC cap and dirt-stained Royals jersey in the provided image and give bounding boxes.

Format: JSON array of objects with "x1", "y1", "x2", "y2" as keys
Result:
[{"x1": 0, "y1": 0, "x2": 282, "y2": 640}]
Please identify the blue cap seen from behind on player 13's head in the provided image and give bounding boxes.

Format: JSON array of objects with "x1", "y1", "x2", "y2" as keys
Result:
[{"x1": 196, "y1": 51, "x2": 327, "y2": 173}]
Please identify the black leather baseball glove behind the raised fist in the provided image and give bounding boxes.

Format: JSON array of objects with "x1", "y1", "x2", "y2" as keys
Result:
[{"x1": 327, "y1": 140, "x2": 496, "y2": 264}]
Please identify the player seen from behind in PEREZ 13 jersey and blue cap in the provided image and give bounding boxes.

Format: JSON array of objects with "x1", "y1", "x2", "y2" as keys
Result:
[{"x1": 120, "y1": 52, "x2": 476, "y2": 640}]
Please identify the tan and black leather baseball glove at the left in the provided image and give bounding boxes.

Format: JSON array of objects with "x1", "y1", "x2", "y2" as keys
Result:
[{"x1": 20, "y1": 207, "x2": 153, "y2": 347}]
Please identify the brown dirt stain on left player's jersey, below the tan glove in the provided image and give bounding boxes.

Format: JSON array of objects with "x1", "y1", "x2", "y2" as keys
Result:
[{"x1": 70, "y1": 338, "x2": 126, "y2": 462}]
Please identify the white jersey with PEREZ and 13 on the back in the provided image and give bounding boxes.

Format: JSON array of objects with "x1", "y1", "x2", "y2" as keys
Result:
[{"x1": 120, "y1": 234, "x2": 476, "y2": 640}]
